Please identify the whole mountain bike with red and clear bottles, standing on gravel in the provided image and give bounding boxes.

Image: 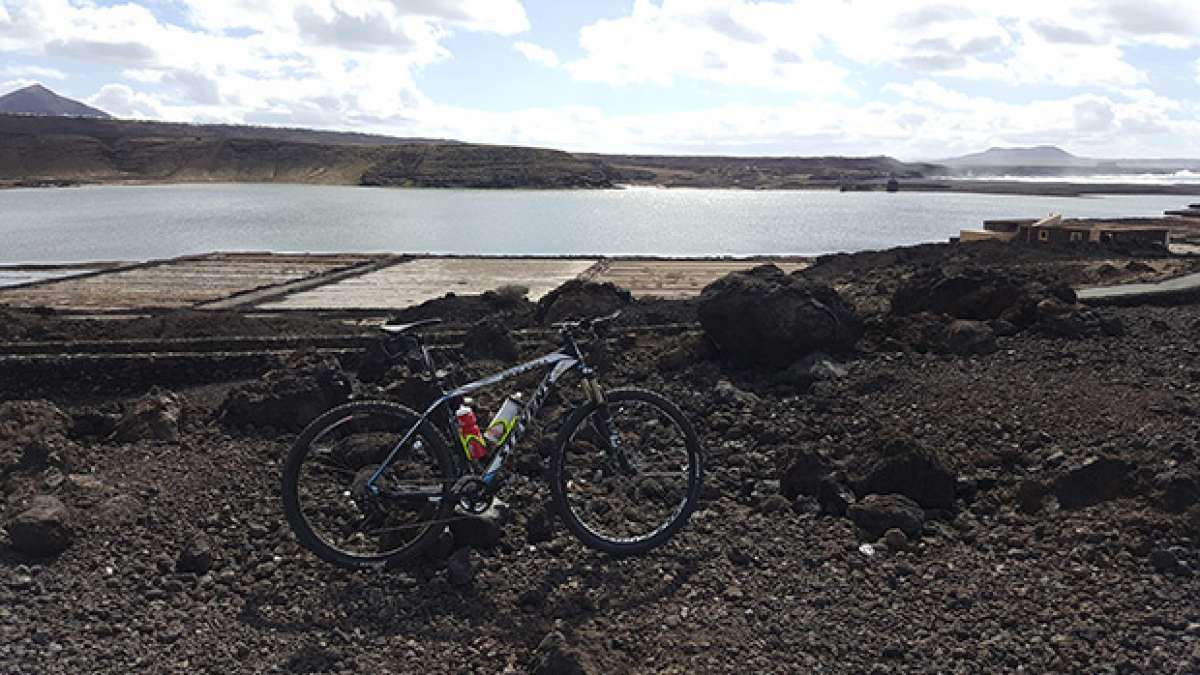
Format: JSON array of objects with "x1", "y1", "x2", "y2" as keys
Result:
[{"x1": 282, "y1": 312, "x2": 703, "y2": 568}]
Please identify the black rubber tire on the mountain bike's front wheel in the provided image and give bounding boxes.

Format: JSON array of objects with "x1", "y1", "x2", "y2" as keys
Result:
[{"x1": 551, "y1": 388, "x2": 704, "y2": 556}]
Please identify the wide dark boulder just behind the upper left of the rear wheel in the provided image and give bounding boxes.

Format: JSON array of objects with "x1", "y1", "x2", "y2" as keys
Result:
[{"x1": 217, "y1": 352, "x2": 352, "y2": 431}]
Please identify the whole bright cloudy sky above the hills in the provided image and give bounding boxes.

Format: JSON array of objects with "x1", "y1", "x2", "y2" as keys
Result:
[{"x1": 0, "y1": 0, "x2": 1200, "y2": 160}]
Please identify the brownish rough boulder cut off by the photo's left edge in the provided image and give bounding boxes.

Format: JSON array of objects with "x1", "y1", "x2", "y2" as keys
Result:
[{"x1": 0, "y1": 401, "x2": 76, "y2": 478}]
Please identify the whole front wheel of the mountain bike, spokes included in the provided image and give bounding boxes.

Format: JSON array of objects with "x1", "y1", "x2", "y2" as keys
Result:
[{"x1": 551, "y1": 389, "x2": 703, "y2": 555}]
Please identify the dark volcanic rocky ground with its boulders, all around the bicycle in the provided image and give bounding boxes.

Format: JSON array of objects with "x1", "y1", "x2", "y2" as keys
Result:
[{"x1": 0, "y1": 240, "x2": 1200, "y2": 673}]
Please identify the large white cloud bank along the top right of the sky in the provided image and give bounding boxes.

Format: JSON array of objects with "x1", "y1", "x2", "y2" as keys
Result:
[{"x1": 568, "y1": 0, "x2": 1200, "y2": 94}]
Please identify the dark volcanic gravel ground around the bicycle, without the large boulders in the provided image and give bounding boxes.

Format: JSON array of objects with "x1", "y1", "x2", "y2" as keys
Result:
[{"x1": 0, "y1": 243, "x2": 1200, "y2": 674}]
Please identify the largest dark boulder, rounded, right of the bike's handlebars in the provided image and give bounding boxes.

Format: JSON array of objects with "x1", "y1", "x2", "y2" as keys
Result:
[{"x1": 698, "y1": 264, "x2": 863, "y2": 366}]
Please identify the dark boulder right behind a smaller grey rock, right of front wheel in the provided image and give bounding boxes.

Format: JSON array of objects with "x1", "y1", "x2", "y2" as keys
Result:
[{"x1": 852, "y1": 436, "x2": 956, "y2": 509}]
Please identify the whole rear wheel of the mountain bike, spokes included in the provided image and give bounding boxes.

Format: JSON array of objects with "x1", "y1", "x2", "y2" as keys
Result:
[{"x1": 282, "y1": 401, "x2": 460, "y2": 568}]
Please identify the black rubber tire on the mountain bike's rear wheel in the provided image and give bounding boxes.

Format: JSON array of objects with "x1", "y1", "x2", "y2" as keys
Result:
[{"x1": 281, "y1": 401, "x2": 462, "y2": 569}]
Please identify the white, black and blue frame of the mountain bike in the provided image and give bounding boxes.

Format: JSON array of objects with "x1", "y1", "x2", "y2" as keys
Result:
[{"x1": 367, "y1": 338, "x2": 602, "y2": 494}]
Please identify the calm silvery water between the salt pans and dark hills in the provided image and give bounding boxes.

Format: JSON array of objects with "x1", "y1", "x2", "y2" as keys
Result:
[{"x1": 0, "y1": 184, "x2": 1200, "y2": 263}]
